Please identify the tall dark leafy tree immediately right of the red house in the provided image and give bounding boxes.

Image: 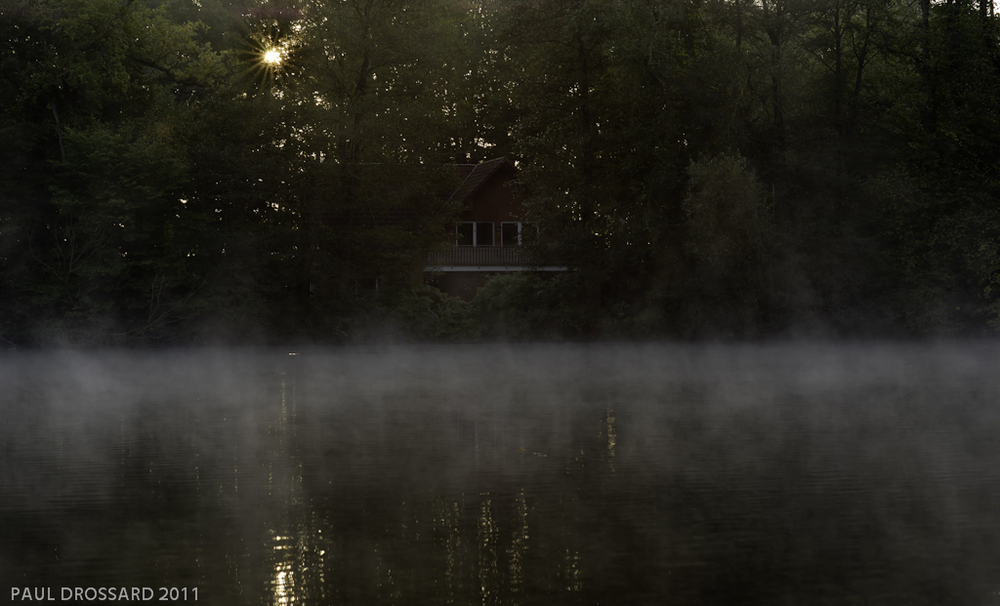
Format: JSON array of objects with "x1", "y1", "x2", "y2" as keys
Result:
[{"x1": 490, "y1": 0, "x2": 714, "y2": 331}]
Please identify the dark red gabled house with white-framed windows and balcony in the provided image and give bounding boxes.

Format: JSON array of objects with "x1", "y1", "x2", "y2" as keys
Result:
[{"x1": 424, "y1": 157, "x2": 566, "y2": 300}]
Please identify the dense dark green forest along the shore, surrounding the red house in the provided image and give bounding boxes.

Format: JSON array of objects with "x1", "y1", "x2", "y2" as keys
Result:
[{"x1": 0, "y1": 0, "x2": 1000, "y2": 347}]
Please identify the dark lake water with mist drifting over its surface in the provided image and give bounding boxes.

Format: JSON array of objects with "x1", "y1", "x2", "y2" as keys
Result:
[{"x1": 0, "y1": 344, "x2": 1000, "y2": 605}]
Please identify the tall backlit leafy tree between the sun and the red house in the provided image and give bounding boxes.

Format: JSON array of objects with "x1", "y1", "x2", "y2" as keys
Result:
[{"x1": 248, "y1": 0, "x2": 474, "y2": 313}]
